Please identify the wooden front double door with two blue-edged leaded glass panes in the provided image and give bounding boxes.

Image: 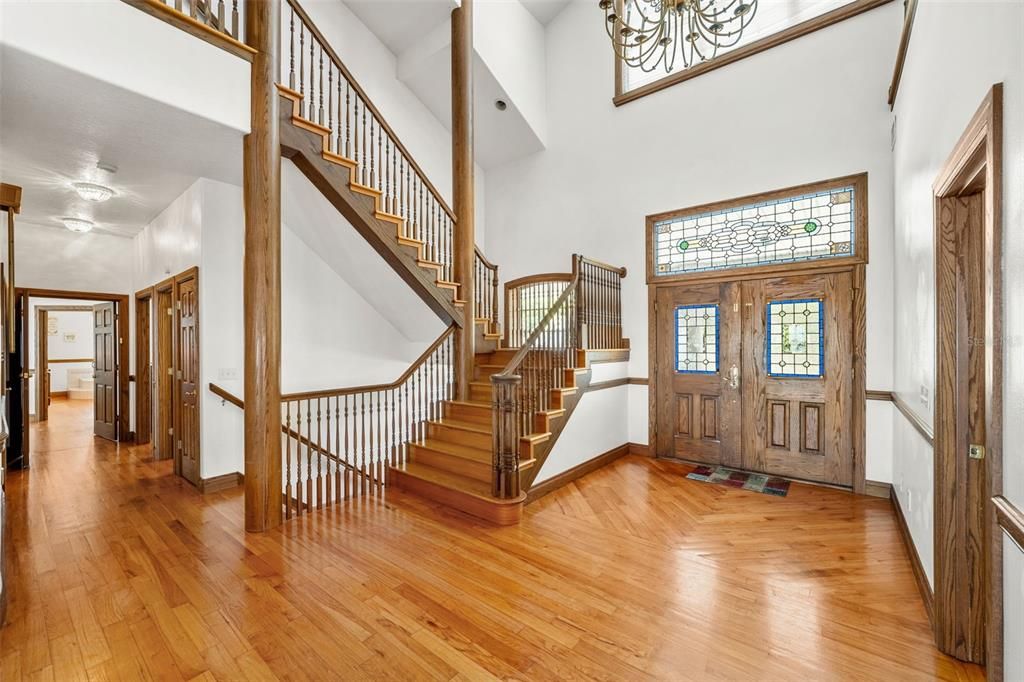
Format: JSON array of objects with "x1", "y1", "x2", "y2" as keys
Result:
[{"x1": 653, "y1": 271, "x2": 854, "y2": 486}]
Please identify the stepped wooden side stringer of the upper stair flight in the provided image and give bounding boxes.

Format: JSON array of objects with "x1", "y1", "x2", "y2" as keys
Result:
[{"x1": 280, "y1": 89, "x2": 465, "y2": 327}]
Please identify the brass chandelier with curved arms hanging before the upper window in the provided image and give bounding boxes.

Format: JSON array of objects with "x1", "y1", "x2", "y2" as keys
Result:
[{"x1": 599, "y1": 0, "x2": 758, "y2": 73}]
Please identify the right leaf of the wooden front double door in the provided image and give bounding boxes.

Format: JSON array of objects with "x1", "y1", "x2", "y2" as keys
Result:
[{"x1": 741, "y1": 272, "x2": 853, "y2": 485}]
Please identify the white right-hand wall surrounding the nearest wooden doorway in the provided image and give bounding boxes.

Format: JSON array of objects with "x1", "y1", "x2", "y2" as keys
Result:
[{"x1": 893, "y1": 0, "x2": 1024, "y2": 659}]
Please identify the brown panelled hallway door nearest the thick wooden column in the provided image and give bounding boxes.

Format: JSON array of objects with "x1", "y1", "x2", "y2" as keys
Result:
[{"x1": 174, "y1": 279, "x2": 200, "y2": 485}]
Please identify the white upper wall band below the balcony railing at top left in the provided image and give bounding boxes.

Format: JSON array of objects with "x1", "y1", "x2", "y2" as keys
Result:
[{"x1": 0, "y1": 0, "x2": 249, "y2": 132}]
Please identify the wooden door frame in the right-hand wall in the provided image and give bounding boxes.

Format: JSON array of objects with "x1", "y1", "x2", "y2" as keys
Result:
[{"x1": 932, "y1": 83, "x2": 1004, "y2": 667}]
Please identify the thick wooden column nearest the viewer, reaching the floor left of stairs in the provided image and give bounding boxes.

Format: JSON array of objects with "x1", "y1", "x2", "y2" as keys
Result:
[{"x1": 243, "y1": 0, "x2": 282, "y2": 531}]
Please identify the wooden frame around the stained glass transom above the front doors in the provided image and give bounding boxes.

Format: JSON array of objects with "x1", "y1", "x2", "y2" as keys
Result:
[{"x1": 645, "y1": 172, "x2": 868, "y2": 285}]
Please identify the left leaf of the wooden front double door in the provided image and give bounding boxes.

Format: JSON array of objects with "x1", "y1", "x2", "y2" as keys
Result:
[{"x1": 655, "y1": 282, "x2": 741, "y2": 466}]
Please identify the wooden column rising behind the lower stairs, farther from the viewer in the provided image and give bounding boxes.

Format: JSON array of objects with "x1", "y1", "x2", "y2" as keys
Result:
[{"x1": 452, "y1": 0, "x2": 476, "y2": 400}]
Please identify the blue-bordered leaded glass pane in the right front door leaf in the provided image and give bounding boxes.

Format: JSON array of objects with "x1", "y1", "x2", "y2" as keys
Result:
[{"x1": 767, "y1": 299, "x2": 825, "y2": 377}]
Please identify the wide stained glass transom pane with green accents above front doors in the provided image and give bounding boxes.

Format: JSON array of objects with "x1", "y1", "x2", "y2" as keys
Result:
[{"x1": 653, "y1": 186, "x2": 856, "y2": 276}]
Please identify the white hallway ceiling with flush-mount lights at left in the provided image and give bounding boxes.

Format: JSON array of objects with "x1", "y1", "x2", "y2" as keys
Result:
[{"x1": 0, "y1": 46, "x2": 242, "y2": 237}]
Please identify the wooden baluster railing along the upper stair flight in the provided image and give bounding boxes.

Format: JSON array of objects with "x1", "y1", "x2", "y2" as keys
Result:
[{"x1": 282, "y1": 0, "x2": 456, "y2": 282}]
